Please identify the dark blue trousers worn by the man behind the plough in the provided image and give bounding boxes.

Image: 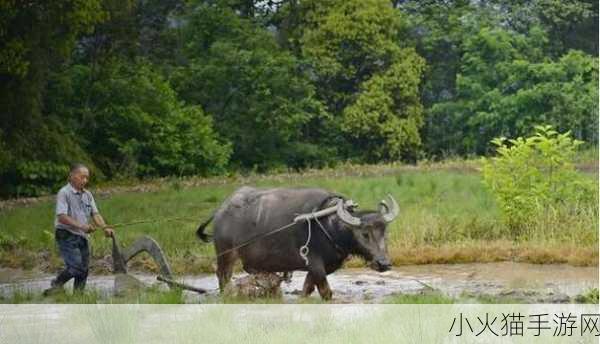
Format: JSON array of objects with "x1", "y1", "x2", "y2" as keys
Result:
[{"x1": 52, "y1": 229, "x2": 90, "y2": 290}]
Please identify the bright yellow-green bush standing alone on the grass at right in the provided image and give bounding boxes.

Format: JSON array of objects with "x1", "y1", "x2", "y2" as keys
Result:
[{"x1": 483, "y1": 126, "x2": 596, "y2": 233}]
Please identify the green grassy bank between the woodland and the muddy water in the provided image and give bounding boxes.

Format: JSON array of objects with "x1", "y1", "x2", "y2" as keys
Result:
[{"x1": 0, "y1": 161, "x2": 598, "y2": 273}]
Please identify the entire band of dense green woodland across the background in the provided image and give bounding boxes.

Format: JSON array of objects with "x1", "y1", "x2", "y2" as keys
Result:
[{"x1": 0, "y1": 0, "x2": 598, "y2": 197}]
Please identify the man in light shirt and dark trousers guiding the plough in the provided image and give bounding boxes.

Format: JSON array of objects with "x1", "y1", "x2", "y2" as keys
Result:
[{"x1": 44, "y1": 164, "x2": 113, "y2": 295}]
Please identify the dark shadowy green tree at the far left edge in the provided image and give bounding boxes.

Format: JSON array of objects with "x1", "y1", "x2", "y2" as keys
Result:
[{"x1": 0, "y1": 0, "x2": 105, "y2": 195}]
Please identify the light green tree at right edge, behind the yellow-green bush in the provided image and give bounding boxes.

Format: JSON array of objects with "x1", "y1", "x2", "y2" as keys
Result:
[{"x1": 430, "y1": 27, "x2": 598, "y2": 154}]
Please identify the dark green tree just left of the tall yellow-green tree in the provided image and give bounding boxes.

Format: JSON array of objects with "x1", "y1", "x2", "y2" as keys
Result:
[{"x1": 173, "y1": 4, "x2": 321, "y2": 170}]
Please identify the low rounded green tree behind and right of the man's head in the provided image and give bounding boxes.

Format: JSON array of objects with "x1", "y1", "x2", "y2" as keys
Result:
[{"x1": 50, "y1": 60, "x2": 230, "y2": 177}]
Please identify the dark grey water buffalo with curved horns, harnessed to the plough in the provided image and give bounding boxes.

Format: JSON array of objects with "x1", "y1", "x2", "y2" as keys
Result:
[{"x1": 196, "y1": 187, "x2": 399, "y2": 300}]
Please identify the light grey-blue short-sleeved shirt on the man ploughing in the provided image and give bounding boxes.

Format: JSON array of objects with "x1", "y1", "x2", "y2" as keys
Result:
[{"x1": 54, "y1": 183, "x2": 98, "y2": 239}]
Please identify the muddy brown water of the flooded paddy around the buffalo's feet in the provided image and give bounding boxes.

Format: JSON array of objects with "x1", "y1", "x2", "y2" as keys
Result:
[{"x1": 0, "y1": 262, "x2": 598, "y2": 303}]
